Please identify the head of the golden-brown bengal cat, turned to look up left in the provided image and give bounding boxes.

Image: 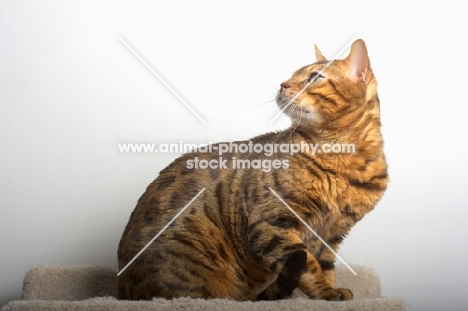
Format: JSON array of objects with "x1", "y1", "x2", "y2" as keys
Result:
[{"x1": 276, "y1": 40, "x2": 379, "y2": 131}]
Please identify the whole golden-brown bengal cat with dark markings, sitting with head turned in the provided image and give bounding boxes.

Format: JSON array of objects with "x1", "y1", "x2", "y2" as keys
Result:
[{"x1": 118, "y1": 40, "x2": 388, "y2": 301}]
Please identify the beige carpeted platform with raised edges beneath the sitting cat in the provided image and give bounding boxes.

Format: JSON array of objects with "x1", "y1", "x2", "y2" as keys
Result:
[{"x1": 1, "y1": 266, "x2": 408, "y2": 311}]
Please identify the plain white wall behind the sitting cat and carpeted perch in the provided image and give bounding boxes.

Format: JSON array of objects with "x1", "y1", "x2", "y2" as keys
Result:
[{"x1": 0, "y1": 0, "x2": 468, "y2": 310}]
